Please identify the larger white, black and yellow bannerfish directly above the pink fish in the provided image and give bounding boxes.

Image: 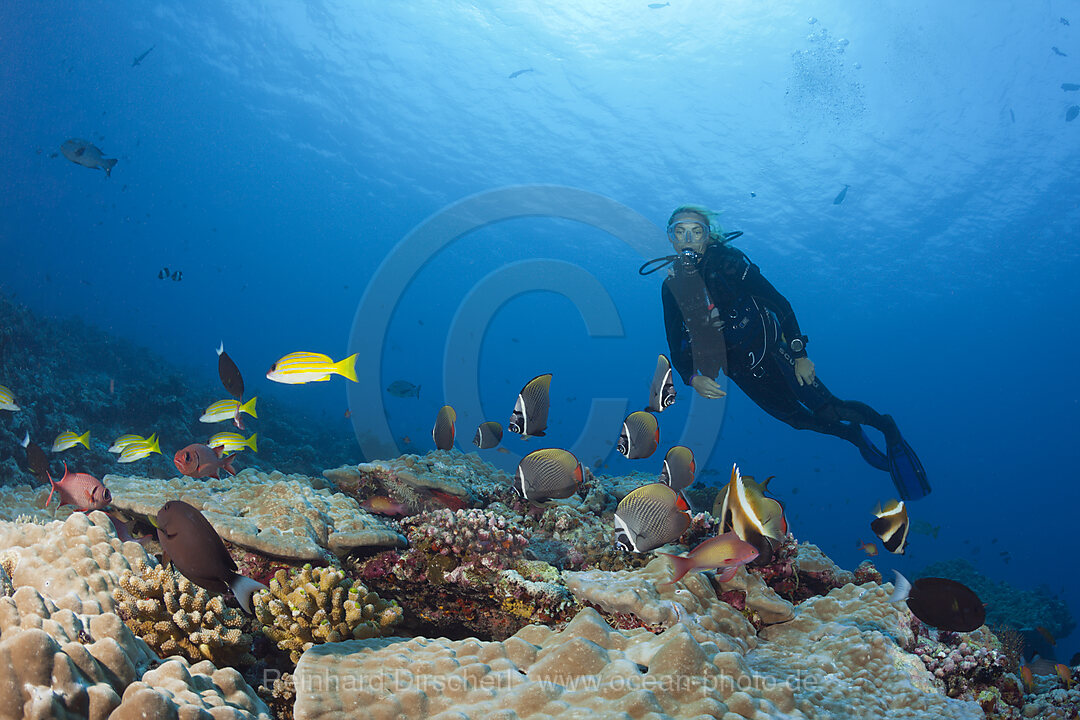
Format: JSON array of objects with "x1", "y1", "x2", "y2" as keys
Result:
[{"x1": 713, "y1": 465, "x2": 787, "y2": 565}]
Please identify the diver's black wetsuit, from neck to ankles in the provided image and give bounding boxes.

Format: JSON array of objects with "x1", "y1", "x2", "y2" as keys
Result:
[{"x1": 661, "y1": 243, "x2": 900, "y2": 455}]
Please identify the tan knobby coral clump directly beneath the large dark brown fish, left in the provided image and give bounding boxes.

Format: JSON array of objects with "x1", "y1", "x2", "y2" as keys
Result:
[{"x1": 113, "y1": 562, "x2": 255, "y2": 667}]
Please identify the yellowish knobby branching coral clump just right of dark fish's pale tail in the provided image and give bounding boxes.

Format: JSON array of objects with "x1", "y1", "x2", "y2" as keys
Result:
[{"x1": 253, "y1": 565, "x2": 402, "y2": 663}]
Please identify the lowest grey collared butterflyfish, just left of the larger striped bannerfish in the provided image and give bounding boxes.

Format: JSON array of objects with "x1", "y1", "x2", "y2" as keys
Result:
[{"x1": 615, "y1": 483, "x2": 690, "y2": 553}]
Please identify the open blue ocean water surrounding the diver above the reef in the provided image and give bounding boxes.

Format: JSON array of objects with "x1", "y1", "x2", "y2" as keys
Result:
[{"x1": 0, "y1": 0, "x2": 1080, "y2": 660}]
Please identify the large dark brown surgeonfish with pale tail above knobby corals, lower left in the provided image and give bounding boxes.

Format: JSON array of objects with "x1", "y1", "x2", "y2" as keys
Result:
[{"x1": 154, "y1": 500, "x2": 267, "y2": 614}]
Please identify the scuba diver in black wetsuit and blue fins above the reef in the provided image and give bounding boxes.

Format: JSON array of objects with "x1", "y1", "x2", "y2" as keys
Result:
[{"x1": 638, "y1": 205, "x2": 930, "y2": 500}]
